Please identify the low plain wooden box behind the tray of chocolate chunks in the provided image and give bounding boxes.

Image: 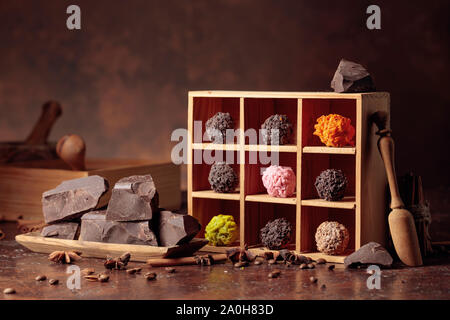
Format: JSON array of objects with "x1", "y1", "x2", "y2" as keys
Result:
[{"x1": 0, "y1": 159, "x2": 181, "y2": 220}]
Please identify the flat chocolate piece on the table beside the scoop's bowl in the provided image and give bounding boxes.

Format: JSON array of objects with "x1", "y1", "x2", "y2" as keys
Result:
[{"x1": 344, "y1": 242, "x2": 393, "y2": 267}]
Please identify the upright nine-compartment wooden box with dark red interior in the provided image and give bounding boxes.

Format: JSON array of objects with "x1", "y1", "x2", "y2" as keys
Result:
[{"x1": 188, "y1": 91, "x2": 390, "y2": 262}]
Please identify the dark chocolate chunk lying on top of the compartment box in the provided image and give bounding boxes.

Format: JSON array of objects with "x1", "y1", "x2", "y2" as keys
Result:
[{"x1": 331, "y1": 59, "x2": 376, "y2": 92}]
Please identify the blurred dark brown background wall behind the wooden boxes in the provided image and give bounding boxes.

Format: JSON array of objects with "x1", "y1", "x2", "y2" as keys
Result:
[{"x1": 0, "y1": 0, "x2": 450, "y2": 236}]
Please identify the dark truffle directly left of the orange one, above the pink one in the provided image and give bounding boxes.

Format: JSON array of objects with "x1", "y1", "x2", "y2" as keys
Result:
[{"x1": 261, "y1": 114, "x2": 293, "y2": 145}]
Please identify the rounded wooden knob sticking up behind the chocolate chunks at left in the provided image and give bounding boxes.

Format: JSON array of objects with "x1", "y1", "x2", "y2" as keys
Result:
[{"x1": 56, "y1": 134, "x2": 86, "y2": 171}]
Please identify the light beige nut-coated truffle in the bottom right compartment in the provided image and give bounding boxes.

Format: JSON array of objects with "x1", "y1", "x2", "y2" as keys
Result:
[{"x1": 316, "y1": 221, "x2": 349, "y2": 255}]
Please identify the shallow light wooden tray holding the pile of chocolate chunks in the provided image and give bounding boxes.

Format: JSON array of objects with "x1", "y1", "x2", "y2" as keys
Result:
[{"x1": 16, "y1": 232, "x2": 208, "y2": 262}]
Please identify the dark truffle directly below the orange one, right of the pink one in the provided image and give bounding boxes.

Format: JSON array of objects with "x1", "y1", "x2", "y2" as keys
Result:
[{"x1": 314, "y1": 169, "x2": 348, "y2": 201}]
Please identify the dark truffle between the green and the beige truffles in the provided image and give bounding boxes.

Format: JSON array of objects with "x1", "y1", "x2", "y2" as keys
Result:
[{"x1": 261, "y1": 218, "x2": 292, "y2": 250}]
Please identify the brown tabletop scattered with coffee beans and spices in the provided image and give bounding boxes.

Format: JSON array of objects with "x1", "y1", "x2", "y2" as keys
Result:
[{"x1": 0, "y1": 223, "x2": 450, "y2": 300}]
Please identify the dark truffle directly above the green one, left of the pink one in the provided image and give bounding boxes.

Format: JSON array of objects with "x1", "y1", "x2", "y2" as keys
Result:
[{"x1": 208, "y1": 162, "x2": 239, "y2": 193}]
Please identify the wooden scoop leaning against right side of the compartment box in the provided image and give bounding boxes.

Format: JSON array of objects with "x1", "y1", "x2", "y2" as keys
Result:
[{"x1": 372, "y1": 112, "x2": 423, "y2": 267}]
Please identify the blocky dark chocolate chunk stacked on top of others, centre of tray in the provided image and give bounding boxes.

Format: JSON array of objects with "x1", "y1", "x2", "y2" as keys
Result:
[{"x1": 106, "y1": 175, "x2": 159, "y2": 221}]
